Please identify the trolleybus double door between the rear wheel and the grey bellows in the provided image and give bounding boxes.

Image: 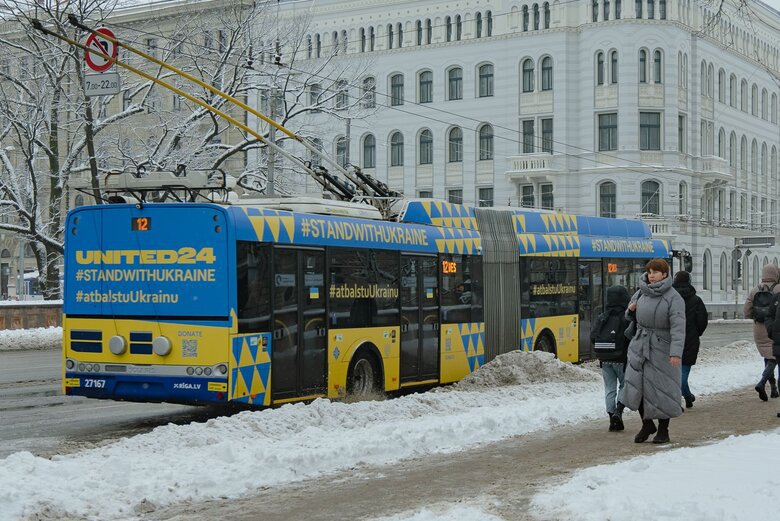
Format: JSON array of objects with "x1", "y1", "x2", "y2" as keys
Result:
[{"x1": 401, "y1": 255, "x2": 439, "y2": 384}]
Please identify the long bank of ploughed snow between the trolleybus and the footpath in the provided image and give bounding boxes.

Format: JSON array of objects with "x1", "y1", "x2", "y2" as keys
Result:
[{"x1": 0, "y1": 342, "x2": 764, "y2": 521}]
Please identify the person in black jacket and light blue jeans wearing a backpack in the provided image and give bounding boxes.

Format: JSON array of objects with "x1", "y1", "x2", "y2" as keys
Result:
[{"x1": 590, "y1": 286, "x2": 630, "y2": 431}]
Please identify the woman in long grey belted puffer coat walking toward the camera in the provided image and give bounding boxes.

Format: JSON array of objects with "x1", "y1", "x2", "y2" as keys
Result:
[{"x1": 621, "y1": 259, "x2": 685, "y2": 443}]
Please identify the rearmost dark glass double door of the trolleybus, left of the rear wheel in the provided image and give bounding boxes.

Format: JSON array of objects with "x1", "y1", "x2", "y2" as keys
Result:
[{"x1": 271, "y1": 248, "x2": 327, "y2": 399}]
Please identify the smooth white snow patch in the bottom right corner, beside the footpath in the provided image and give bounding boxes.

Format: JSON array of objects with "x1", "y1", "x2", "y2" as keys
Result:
[{"x1": 532, "y1": 429, "x2": 780, "y2": 521}]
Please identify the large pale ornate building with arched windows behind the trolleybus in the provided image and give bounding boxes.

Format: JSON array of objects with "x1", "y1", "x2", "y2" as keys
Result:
[{"x1": 274, "y1": 0, "x2": 780, "y2": 317}]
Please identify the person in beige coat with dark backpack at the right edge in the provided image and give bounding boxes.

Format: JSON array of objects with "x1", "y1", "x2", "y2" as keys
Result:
[{"x1": 743, "y1": 264, "x2": 780, "y2": 401}]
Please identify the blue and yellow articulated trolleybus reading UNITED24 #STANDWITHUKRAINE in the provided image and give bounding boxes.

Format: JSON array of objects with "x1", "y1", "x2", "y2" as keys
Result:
[{"x1": 63, "y1": 174, "x2": 671, "y2": 406}]
